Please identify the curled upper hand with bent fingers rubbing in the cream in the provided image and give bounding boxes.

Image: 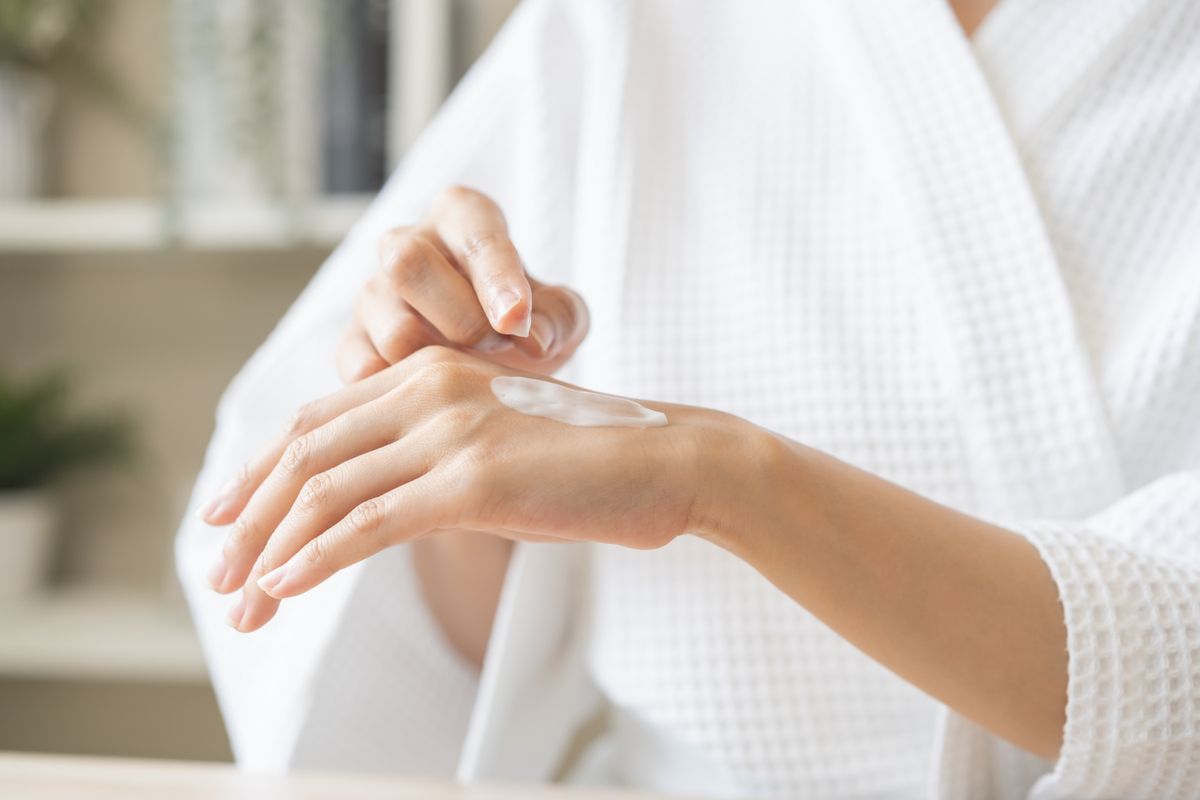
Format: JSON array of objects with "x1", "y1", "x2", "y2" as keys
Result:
[{"x1": 337, "y1": 187, "x2": 588, "y2": 383}]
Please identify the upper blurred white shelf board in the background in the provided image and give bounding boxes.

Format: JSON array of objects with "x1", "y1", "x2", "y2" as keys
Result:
[{"x1": 0, "y1": 194, "x2": 371, "y2": 253}]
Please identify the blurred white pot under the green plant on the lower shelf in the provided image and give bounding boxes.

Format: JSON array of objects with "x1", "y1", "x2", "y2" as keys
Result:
[{"x1": 0, "y1": 489, "x2": 58, "y2": 602}]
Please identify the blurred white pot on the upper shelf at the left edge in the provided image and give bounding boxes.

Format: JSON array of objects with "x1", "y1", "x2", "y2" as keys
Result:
[{"x1": 0, "y1": 64, "x2": 54, "y2": 200}]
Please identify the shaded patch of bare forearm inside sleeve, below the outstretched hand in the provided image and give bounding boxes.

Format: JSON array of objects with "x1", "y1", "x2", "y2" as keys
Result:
[{"x1": 409, "y1": 530, "x2": 512, "y2": 667}]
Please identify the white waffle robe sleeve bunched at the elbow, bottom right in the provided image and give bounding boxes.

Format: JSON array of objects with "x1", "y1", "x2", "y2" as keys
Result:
[{"x1": 938, "y1": 465, "x2": 1200, "y2": 800}]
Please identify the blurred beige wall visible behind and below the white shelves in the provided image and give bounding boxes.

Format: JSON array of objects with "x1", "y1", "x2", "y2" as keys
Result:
[{"x1": 0, "y1": 0, "x2": 514, "y2": 758}]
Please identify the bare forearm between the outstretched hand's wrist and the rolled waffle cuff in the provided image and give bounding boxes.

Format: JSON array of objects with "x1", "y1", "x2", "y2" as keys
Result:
[{"x1": 706, "y1": 429, "x2": 1067, "y2": 758}]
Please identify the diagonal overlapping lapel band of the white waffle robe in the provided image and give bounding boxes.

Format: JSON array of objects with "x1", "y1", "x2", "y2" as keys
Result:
[{"x1": 846, "y1": 0, "x2": 1122, "y2": 518}]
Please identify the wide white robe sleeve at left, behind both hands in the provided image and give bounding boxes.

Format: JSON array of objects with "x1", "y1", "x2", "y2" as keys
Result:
[{"x1": 176, "y1": 0, "x2": 588, "y2": 776}]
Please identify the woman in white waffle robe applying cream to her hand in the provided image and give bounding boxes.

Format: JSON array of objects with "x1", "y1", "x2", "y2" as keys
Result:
[{"x1": 179, "y1": 0, "x2": 1200, "y2": 798}]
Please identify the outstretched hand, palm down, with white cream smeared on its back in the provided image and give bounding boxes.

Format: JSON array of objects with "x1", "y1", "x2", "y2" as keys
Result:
[{"x1": 201, "y1": 347, "x2": 754, "y2": 631}]
